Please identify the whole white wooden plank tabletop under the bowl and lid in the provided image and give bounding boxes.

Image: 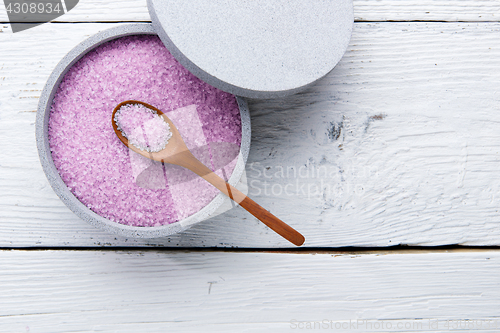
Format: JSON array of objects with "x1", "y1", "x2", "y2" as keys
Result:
[{"x1": 0, "y1": 0, "x2": 500, "y2": 333}]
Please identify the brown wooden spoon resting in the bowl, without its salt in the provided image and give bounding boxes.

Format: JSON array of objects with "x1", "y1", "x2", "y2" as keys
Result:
[{"x1": 111, "y1": 100, "x2": 305, "y2": 246}]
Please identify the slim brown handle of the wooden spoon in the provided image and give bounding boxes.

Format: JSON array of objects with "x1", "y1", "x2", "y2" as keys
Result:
[{"x1": 174, "y1": 151, "x2": 305, "y2": 246}]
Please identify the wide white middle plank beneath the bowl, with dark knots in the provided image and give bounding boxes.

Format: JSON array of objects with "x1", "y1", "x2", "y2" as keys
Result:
[{"x1": 0, "y1": 23, "x2": 500, "y2": 247}]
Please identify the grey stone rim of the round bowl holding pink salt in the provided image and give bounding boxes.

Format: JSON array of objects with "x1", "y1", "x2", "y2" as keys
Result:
[{"x1": 36, "y1": 24, "x2": 251, "y2": 238}]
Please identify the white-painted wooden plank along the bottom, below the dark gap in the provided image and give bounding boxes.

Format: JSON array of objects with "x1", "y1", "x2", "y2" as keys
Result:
[{"x1": 0, "y1": 251, "x2": 500, "y2": 333}]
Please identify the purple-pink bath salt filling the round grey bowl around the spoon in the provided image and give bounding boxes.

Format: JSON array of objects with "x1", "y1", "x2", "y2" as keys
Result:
[{"x1": 48, "y1": 35, "x2": 241, "y2": 227}]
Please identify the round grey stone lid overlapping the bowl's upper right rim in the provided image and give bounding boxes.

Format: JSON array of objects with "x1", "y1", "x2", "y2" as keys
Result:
[{"x1": 148, "y1": 0, "x2": 354, "y2": 98}]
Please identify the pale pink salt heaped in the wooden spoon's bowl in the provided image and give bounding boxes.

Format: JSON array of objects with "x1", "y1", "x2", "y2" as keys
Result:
[{"x1": 114, "y1": 104, "x2": 172, "y2": 153}]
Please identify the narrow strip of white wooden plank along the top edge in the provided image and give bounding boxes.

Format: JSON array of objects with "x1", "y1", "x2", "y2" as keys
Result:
[{"x1": 0, "y1": 0, "x2": 500, "y2": 22}]
